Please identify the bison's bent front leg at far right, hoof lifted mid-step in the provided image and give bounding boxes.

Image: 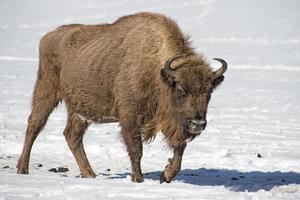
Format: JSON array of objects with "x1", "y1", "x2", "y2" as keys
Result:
[{"x1": 160, "y1": 143, "x2": 186, "y2": 183}]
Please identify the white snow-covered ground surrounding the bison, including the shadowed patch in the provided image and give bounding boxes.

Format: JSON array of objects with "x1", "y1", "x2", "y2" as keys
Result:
[{"x1": 0, "y1": 0, "x2": 300, "y2": 200}]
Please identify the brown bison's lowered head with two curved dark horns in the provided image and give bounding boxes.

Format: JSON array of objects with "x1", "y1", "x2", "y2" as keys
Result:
[{"x1": 161, "y1": 55, "x2": 227, "y2": 135}]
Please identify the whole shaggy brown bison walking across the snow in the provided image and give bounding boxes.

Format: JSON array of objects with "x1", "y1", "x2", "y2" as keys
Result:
[{"x1": 17, "y1": 13, "x2": 227, "y2": 182}]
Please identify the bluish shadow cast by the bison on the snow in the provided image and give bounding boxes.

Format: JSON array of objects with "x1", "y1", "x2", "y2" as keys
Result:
[{"x1": 99, "y1": 168, "x2": 300, "y2": 192}]
